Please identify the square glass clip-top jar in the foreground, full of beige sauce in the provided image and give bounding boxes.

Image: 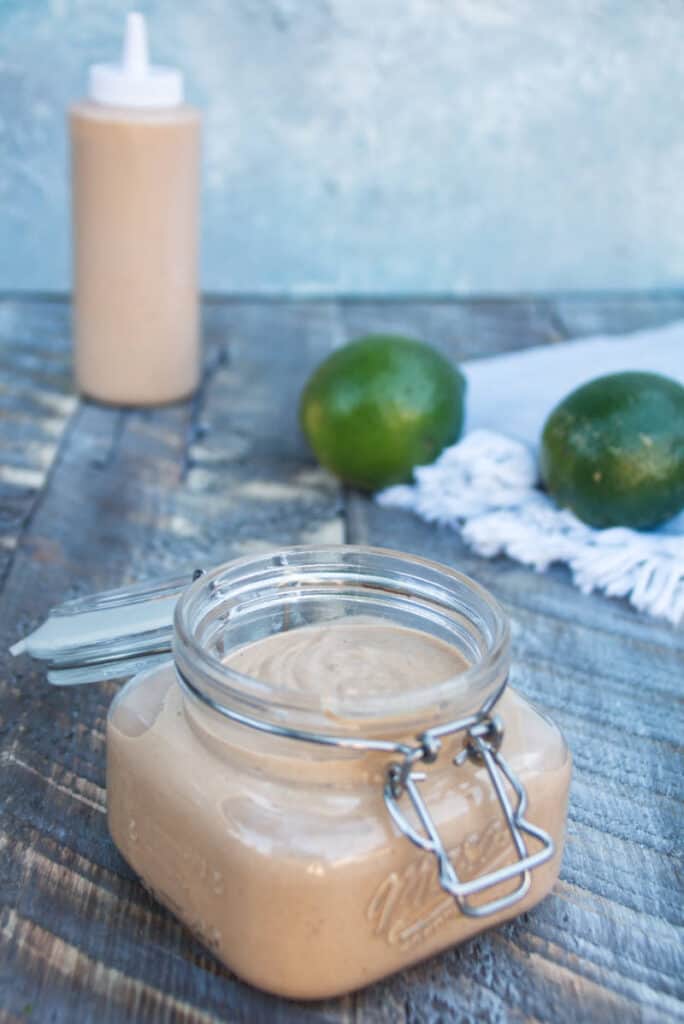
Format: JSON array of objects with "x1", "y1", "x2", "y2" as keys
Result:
[{"x1": 14, "y1": 546, "x2": 570, "y2": 998}]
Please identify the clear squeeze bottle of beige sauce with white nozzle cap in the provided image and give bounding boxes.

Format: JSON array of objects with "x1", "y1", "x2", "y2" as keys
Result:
[{"x1": 70, "y1": 13, "x2": 200, "y2": 406}]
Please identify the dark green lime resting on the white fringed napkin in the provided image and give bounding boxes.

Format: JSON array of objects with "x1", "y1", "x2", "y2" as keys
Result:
[{"x1": 541, "y1": 373, "x2": 684, "y2": 529}]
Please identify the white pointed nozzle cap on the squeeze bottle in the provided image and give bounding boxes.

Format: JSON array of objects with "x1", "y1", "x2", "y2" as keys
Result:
[{"x1": 88, "y1": 12, "x2": 183, "y2": 108}]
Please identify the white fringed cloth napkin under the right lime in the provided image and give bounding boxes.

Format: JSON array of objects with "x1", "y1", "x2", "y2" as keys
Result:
[{"x1": 376, "y1": 322, "x2": 684, "y2": 623}]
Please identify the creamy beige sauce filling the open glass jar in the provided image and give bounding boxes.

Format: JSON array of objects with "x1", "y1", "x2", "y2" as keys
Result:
[{"x1": 108, "y1": 624, "x2": 570, "y2": 998}]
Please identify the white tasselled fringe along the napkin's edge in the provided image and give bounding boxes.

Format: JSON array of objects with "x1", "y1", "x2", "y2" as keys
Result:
[{"x1": 376, "y1": 430, "x2": 684, "y2": 624}]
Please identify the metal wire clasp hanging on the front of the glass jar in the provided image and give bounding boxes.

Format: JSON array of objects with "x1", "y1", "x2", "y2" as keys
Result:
[{"x1": 384, "y1": 715, "x2": 555, "y2": 918}]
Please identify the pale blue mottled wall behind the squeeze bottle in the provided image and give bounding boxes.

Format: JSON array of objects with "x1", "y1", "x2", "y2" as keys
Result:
[{"x1": 0, "y1": 0, "x2": 684, "y2": 292}]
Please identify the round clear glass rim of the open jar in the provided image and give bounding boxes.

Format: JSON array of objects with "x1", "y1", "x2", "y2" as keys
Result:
[{"x1": 173, "y1": 545, "x2": 510, "y2": 734}]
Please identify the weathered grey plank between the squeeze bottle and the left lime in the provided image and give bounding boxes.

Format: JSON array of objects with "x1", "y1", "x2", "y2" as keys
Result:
[{"x1": 163, "y1": 302, "x2": 344, "y2": 577}]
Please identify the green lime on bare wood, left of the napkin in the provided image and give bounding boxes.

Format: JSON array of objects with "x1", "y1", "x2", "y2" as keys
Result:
[{"x1": 299, "y1": 335, "x2": 466, "y2": 490}]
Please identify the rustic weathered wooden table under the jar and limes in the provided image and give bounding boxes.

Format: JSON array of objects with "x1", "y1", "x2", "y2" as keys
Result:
[{"x1": 0, "y1": 295, "x2": 684, "y2": 1024}]
